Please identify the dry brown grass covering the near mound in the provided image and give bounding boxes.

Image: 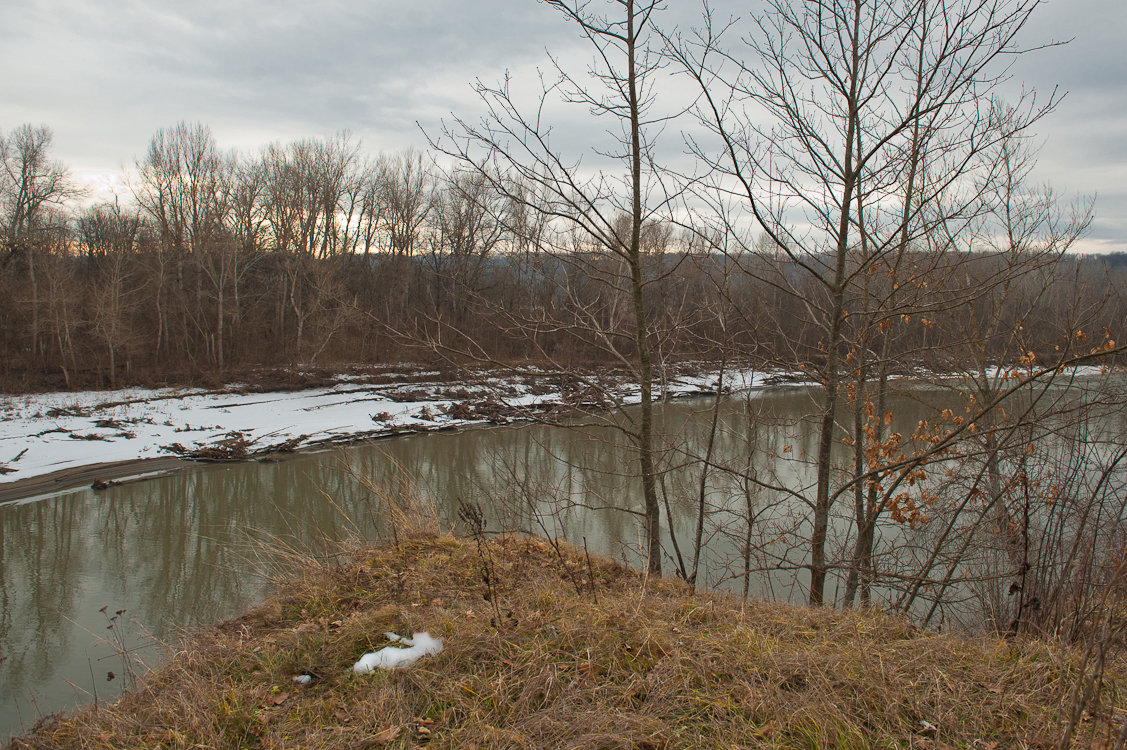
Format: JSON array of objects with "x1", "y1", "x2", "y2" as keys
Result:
[{"x1": 12, "y1": 536, "x2": 1125, "y2": 748}]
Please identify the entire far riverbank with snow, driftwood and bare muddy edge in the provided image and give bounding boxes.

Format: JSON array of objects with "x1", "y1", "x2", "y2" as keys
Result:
[{"x1": 0, "y1": 362, "x2": 1103, "y2": 503}]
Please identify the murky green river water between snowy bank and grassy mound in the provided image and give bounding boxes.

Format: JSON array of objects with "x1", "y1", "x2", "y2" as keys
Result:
[{"x1": 0, "y1": 388, "x2": 1099, "y2": 740}]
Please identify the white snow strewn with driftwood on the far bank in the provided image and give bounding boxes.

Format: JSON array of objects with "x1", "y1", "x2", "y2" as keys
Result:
[{"x1": 0, "y1": 363, "x2": 767, "y2": 486}]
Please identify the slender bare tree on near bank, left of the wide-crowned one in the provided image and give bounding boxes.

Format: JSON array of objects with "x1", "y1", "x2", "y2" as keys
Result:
[{"x1": 428, "y1": 0, "x2": 671, "y2": 573}]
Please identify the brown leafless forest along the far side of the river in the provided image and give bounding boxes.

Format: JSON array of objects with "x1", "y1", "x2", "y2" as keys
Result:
[{"x1": 0, "y1": 123, "x2": 1127, "y2": 391}]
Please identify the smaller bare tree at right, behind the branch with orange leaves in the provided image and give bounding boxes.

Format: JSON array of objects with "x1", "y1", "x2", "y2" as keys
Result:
[{"x1": 902, "y1": 125, "x2": 1113, "y2": 630}]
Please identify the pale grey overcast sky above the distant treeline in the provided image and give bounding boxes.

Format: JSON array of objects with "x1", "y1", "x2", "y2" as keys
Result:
[{"x1": 0, "y1": 0, "x2": 1127, "y2": 250}]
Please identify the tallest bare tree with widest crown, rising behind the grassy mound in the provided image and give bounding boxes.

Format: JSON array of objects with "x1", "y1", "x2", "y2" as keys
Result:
[{"x1": 674, "y1": 0, "x2": 1068, "y2": 605}]
